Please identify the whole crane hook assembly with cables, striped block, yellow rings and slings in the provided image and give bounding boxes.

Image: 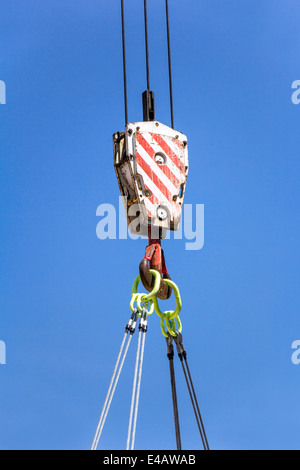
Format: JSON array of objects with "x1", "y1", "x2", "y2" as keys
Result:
[{"x1": 91, "y1": 0, "x2": 209, "y2": 450}]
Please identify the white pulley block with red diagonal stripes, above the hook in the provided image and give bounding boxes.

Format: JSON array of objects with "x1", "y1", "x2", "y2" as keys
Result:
[{"x1": 113, "y1": 121, "x2": 189, "y2": 238}]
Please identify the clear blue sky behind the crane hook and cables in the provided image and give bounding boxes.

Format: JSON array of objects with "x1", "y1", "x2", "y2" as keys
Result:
[{"x1": 0, "y1": 0, "x2": 300, "y2": 449}]
